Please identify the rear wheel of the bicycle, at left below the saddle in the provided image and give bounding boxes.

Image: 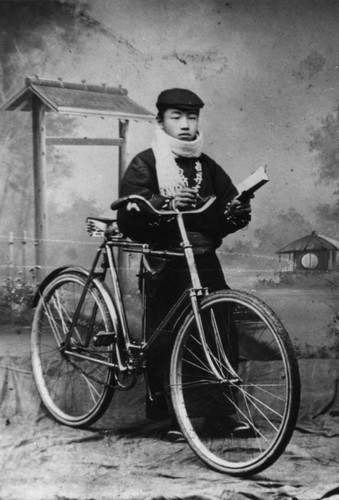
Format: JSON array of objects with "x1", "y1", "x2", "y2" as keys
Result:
[{"x1": 31, "y1": 271, "x2": 114, "y2": 427}]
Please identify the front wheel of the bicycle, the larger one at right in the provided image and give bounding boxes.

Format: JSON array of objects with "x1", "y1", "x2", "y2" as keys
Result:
[{"x1": 170, "y1": 290, "x2": 300, "y2": 476}]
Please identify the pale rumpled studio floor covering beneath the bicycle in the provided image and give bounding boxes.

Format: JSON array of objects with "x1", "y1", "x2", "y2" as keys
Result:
[{"x1": 0, "y1": 328, "x2": 339, "y2": 500}]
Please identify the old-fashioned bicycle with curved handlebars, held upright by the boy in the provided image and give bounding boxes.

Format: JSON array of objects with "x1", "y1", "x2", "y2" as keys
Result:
[{"x1": 31, "y1": 195, "x2": 300, "y2": 476}]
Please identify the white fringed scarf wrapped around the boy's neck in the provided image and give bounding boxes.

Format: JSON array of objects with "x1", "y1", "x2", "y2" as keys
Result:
[{"x1": 152, "y1": 124, "x2": 203, "y2": 196}]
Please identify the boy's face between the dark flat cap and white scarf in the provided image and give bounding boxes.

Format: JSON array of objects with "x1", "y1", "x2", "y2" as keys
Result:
[{"x1": 160, "y1": 109, "x2": 199, "y2": 141}]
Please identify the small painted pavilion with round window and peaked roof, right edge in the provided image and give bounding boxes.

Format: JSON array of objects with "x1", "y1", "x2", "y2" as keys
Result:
[{"x1": 277, "y1": 231, "x2": 339, "y2": 272}]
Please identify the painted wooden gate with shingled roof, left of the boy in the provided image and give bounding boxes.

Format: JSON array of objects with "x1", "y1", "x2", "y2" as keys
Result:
[{"x1": 0, "y1": 77, "x2": 155, "y2": 278}]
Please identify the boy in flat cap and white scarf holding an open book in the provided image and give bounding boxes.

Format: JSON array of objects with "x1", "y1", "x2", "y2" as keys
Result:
[{"x1": 118, "y1": 88, "x2": 251, "y2": 440}]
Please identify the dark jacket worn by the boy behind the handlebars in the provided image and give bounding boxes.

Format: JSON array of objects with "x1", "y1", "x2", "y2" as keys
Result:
[{"x1": 118, "y1": 149, "x2": 238, "y2": 248}]
